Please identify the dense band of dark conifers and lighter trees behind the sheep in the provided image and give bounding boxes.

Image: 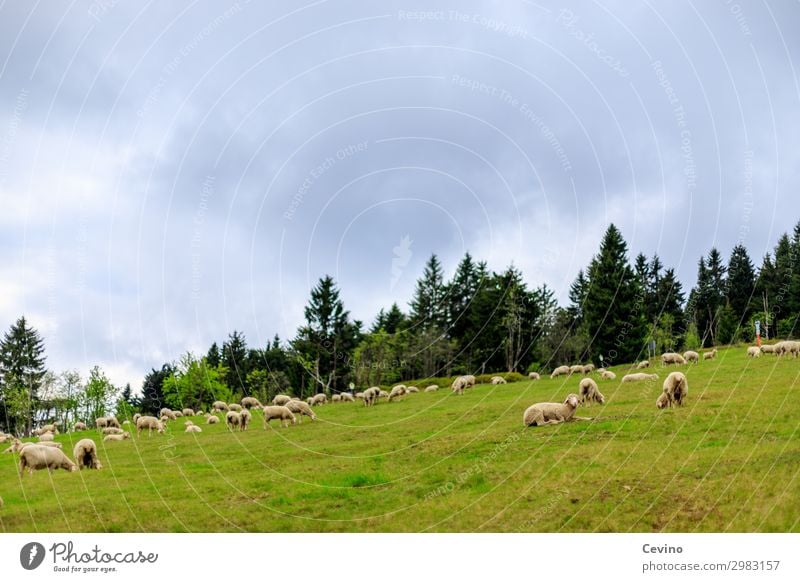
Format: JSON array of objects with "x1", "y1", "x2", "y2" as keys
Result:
[{"x1": 0, "y1": 223, "x2": 800, "y2": 434}]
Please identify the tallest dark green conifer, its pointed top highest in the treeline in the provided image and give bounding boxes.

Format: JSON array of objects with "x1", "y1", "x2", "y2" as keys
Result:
[{"x1": 584, "y1": 224, "x2": 647, "y2": 364}]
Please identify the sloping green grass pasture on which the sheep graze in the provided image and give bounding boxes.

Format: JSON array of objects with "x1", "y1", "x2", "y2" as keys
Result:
[{"x1": 0, "y1": 348, "x2": 800, "y2": 532}]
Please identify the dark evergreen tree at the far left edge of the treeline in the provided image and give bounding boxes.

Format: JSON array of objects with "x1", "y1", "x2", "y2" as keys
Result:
[{"x1": 0, "y1": 317, "x2": 46, "y2": 435}]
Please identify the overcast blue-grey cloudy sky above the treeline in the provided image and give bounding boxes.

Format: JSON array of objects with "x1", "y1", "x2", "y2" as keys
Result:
[{"x1": 0, "y1": 0, "x2": 800, "y2": 388}]
